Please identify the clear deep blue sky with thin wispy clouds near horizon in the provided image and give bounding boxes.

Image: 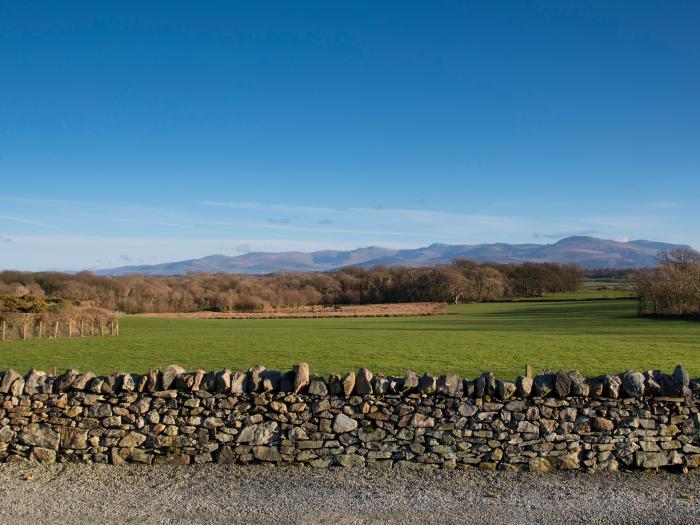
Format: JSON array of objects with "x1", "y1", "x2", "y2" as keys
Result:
[{"x1": 0, "y1": 0, "x2": 700, "y2": 270}]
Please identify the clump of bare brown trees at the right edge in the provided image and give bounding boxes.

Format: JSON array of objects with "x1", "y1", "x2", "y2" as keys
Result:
[{"x1": 634, "y1": 248, "x2": 700, "y2": 317}]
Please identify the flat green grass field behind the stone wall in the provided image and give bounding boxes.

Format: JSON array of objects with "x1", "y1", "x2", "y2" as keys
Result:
[{"x1": 0, "y1": 300, "x2": 700, "y2": 378}]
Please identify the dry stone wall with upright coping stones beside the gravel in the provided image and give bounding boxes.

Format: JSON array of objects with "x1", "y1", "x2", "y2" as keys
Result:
[{"x1": 0, "y1": 363, "x2": 700, "y2": 472}]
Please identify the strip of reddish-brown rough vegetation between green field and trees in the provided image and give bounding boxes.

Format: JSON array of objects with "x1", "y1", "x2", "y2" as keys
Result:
[{"x1": 135, "y1": 303, "x2": 449, "y2": 319}]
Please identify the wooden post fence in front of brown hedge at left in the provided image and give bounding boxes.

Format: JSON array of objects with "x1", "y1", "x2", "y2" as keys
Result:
[{"x1": 0, "y1": 312, "x2": 119, "y2": 341}]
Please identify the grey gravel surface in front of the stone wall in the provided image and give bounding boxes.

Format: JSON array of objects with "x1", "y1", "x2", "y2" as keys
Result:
[{"x1": 0, "y1": 464, "x2": 700, "y2": 524}]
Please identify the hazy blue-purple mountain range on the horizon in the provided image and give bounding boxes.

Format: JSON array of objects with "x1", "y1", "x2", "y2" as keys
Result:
[{"x1": 96, "y1": 236, "x2": 690, "y2": 275}]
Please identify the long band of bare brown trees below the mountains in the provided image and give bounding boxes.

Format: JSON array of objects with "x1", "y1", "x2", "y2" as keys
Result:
[{"x1": 0, "y1": 260, "x2": 584, "y2": 313}]
